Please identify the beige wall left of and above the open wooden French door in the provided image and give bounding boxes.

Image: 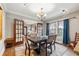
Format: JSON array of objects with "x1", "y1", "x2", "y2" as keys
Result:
[{"x1": 5, "y1": 13, "x2": 29, "y2": 38}]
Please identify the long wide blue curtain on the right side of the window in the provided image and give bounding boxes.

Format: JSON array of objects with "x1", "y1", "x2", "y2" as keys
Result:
[{"x1": 63, "y1": 19, "x2": 69, "y2": 45}]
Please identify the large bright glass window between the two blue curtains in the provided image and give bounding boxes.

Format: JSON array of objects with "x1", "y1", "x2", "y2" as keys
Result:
[{"x1": 49, "y1": 21, "x2": 63, "y2": 43}]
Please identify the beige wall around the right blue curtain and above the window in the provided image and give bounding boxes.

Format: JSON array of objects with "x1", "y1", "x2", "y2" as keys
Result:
[{"x1": 46, "y1": 11, "x2": 79, "y2": 41}]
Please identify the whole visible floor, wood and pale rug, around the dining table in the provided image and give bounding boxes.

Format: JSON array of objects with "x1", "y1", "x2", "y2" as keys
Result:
[{"x1": 3, "y1": 44, "x2": 77, "y2": 56}]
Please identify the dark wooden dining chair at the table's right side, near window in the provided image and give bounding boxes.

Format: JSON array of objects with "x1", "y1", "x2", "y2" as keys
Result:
[{"x1": 40, "y1": 34, "x2": 57, "y2": 55}]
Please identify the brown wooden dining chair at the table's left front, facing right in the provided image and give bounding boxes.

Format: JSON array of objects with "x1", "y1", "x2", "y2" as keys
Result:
[{"x1": 23, "y1": 35, "x2": 38, "y2": 56}]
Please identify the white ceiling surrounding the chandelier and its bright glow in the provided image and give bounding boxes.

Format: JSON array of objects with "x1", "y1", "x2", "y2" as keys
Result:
[{"x1": 3, "y1": 3, "x2": 79, "y2": 20}]
